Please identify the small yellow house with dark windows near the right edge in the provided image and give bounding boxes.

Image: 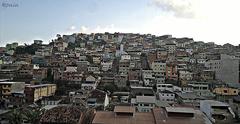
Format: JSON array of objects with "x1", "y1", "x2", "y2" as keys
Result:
[{"x1": 213, "y1": 87, "x2": 239, "y2": 96}]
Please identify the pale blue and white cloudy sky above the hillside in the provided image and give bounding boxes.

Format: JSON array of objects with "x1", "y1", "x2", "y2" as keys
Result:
[{"x1": 0, "y1": 0, "x2": 240, "y2": 46}]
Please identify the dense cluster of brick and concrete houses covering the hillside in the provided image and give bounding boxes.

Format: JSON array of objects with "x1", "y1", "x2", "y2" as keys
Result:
[{"x1": 0, "y1": 32, "x2": 240, "y2": 124}]
